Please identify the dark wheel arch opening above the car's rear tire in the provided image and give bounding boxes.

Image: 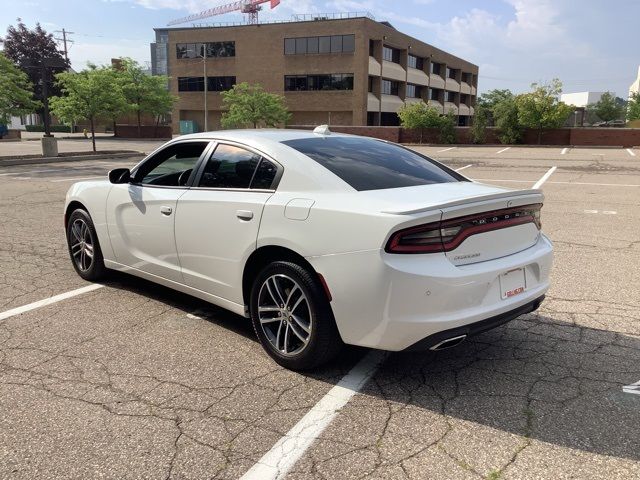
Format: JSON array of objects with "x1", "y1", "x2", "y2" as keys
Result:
[{"x1": 242, "y1": 245, "x2": 331, "y2": 305}]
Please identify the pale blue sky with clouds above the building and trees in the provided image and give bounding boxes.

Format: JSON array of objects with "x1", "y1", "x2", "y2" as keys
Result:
[{"x1": 0, "y1": 0, "x2": 640, "y2": 98}]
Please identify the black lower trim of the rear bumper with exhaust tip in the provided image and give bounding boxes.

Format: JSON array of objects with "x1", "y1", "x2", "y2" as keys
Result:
[{"x1": 406, "y1": 295, "x2": 544, "y2": 351}]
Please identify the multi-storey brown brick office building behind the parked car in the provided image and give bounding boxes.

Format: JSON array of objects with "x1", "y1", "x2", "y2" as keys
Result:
[{"x1": 151, "y1": 16, "x2": 478, "y2": 132}]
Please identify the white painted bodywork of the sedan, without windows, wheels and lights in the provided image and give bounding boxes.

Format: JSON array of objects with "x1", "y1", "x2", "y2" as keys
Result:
[{"x1": 65, "y1": 130, "x2": 553, "y2": 351}]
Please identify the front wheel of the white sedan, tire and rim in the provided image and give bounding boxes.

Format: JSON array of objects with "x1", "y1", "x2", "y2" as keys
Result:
[{"x1": 67, "y1": 208, "x2": 107, "y2": 282}]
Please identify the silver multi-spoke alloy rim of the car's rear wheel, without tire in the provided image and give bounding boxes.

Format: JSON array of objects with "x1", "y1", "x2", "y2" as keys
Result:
[{"x1": 258, "y1": 274, "x2": 313, "y2": 356}]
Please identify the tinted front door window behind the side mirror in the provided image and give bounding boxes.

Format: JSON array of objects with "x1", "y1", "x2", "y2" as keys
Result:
[{"x1": 134, "y1": 142, "x2": 209, "y2": 187}]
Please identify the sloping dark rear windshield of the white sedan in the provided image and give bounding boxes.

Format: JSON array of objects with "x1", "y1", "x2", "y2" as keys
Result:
[{"x1": 282, "y1": 137, "x2": 464, "y2": 191}]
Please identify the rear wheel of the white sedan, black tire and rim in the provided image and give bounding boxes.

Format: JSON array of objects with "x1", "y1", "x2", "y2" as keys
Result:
[{"x1": 250, "y1": 261, "x2": 344, "y2": 370}]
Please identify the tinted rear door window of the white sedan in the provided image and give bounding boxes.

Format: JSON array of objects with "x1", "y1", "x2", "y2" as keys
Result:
[{"x1": 198, "y1": 144, "x2": 260, "y2": 188}]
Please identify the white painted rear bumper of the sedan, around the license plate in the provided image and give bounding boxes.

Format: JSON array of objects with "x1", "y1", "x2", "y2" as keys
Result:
[{"x1": 307, "y1": 235, "x2": 553, "y2": 351}]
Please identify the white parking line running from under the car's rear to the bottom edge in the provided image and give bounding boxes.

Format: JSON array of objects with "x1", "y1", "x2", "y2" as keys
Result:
[{"x1": 241, "y1": 350, "x2": 386, "y2": 480}]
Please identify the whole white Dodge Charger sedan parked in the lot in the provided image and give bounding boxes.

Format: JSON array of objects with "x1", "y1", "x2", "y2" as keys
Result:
[{"x1": 64, "y1": 126, "x2": 553, "y2": 369}]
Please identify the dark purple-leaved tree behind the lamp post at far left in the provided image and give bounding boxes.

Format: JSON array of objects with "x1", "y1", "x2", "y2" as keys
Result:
[{"x1": 0, "y1": 22, "x2": 70, "y2": 108}]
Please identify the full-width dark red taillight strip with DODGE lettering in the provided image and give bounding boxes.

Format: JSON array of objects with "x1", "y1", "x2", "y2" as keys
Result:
[{"x1": 385, "y1": 203, "x2": 542, "y2": 253}]
